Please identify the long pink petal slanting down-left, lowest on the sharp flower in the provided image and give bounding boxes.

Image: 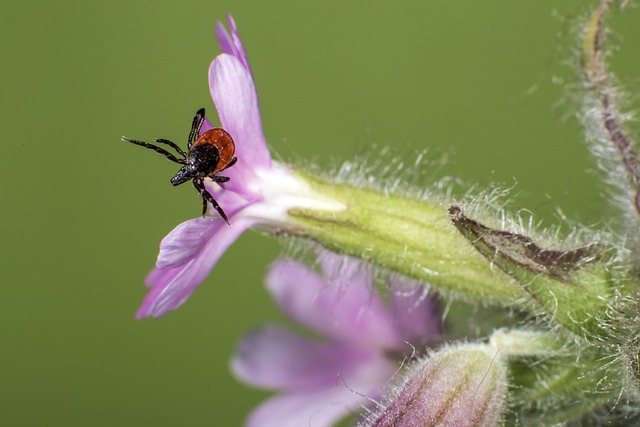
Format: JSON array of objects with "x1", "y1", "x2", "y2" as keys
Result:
[{"x1": 137, "y1": 214, "x2": 255, "y2": 318}]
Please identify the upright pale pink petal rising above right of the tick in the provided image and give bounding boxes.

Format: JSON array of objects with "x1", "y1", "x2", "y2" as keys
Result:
[{"x1": 209, "y1": 53, "x2": 271, "y2": 191}]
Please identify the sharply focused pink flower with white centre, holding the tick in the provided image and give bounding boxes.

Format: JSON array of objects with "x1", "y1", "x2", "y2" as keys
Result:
[{"x1": 136, "y1": 16, "x2": 342, "y2": 318}]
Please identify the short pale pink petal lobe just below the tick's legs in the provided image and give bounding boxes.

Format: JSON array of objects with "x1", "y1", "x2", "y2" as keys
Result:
[{"x1": 156, "y1": 217, "x2": 220, "y2": 270}]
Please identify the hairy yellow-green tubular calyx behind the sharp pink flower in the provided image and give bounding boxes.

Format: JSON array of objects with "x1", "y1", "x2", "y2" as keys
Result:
[{"x1": 289, "y1": 170, "x2": 524, "y2": 304}]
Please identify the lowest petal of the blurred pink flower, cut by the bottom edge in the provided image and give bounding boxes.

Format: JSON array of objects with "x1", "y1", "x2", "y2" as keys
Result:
[{"x1": 246, "y1": 383, "x2": 370, "y2": 427}]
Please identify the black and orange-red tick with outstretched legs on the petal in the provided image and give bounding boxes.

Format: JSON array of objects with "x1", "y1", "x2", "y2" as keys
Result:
[{"x1": 122, "y1": 108, "x2": 238, "y2": 224}]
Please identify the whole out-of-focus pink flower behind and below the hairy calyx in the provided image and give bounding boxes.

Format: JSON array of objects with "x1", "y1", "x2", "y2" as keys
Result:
[{"x1": 232, "y1": 254, "x2": 442, "y2": 427}]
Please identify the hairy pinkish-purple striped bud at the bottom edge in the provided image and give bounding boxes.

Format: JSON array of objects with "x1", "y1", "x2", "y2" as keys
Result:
[{"x1": 363, "y1": 344, "x2": 507, "y2": 427}]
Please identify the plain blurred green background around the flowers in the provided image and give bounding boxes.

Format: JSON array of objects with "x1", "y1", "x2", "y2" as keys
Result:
[{"x1": 0, "y1": 0, "x2": 640, "y2": 426}]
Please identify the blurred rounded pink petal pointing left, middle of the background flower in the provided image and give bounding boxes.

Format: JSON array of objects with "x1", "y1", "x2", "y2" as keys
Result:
[{"x1": 231, "y1": 326, "x2": 378, "y2": 390}]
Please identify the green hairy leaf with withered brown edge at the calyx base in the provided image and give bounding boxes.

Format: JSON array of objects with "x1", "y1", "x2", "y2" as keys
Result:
[{"x1": 449, "y1": 206, "x2": 616, "y2": 336}]
